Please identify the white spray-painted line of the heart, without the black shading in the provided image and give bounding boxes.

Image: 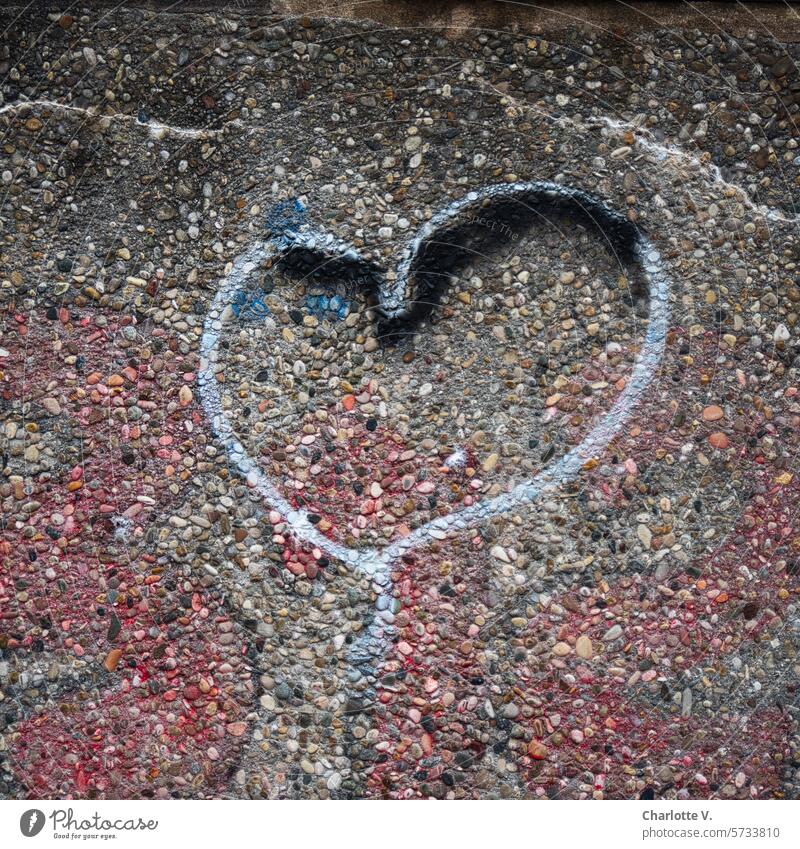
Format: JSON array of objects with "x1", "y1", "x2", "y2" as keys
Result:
[{"x1": 197, "y1": 181, "x2": 670, "y2": 587}]
